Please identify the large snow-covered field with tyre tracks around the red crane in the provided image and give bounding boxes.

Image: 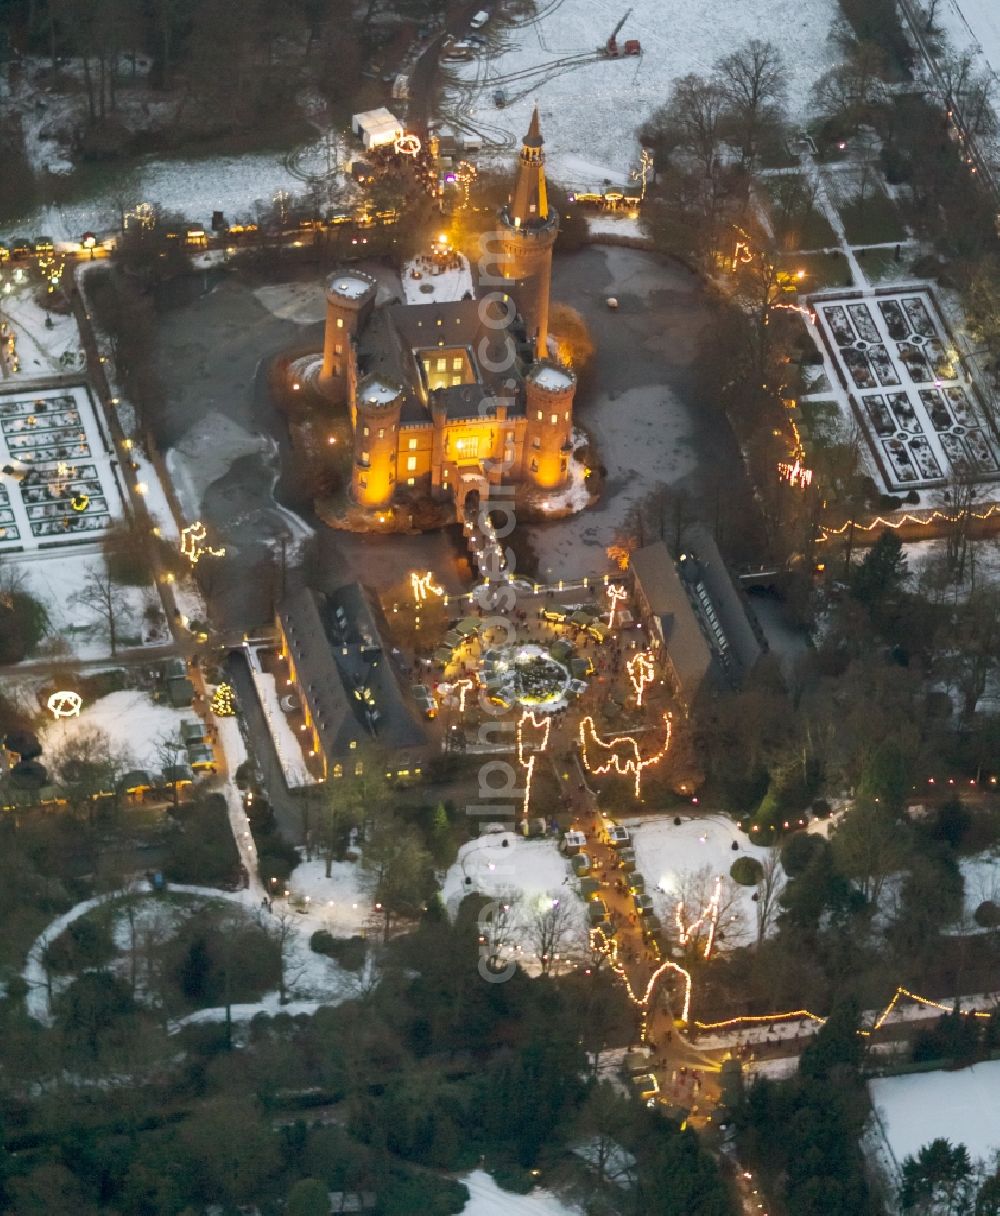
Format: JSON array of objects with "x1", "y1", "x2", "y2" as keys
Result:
[{"x1": 442, "y1": 0, "x2": 841, "y2": 188}]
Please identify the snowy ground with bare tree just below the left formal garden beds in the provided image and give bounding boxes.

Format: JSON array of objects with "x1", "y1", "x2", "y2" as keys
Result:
[{"x1": 4, "y1": 546, "x2": 170, "y2": 659}]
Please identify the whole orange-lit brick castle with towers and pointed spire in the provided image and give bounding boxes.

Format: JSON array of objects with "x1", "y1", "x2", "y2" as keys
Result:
[{"x1": 320, "y1": 111, "x2": 577, "y2": 516}]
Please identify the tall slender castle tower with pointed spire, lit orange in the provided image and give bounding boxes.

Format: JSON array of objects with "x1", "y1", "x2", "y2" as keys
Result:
[{"x1": 498, "y1": 107, "x2": 560, "y2": 359}]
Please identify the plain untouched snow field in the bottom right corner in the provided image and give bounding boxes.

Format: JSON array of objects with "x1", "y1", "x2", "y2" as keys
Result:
[{"x1": 869, "y1": 1060, "x2": 1000, "y2": 1165}]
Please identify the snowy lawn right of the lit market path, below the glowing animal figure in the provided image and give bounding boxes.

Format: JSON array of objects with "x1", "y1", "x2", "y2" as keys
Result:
[{"x1": 624, "y1": 815, "x2": 783, "y2": 946}]
